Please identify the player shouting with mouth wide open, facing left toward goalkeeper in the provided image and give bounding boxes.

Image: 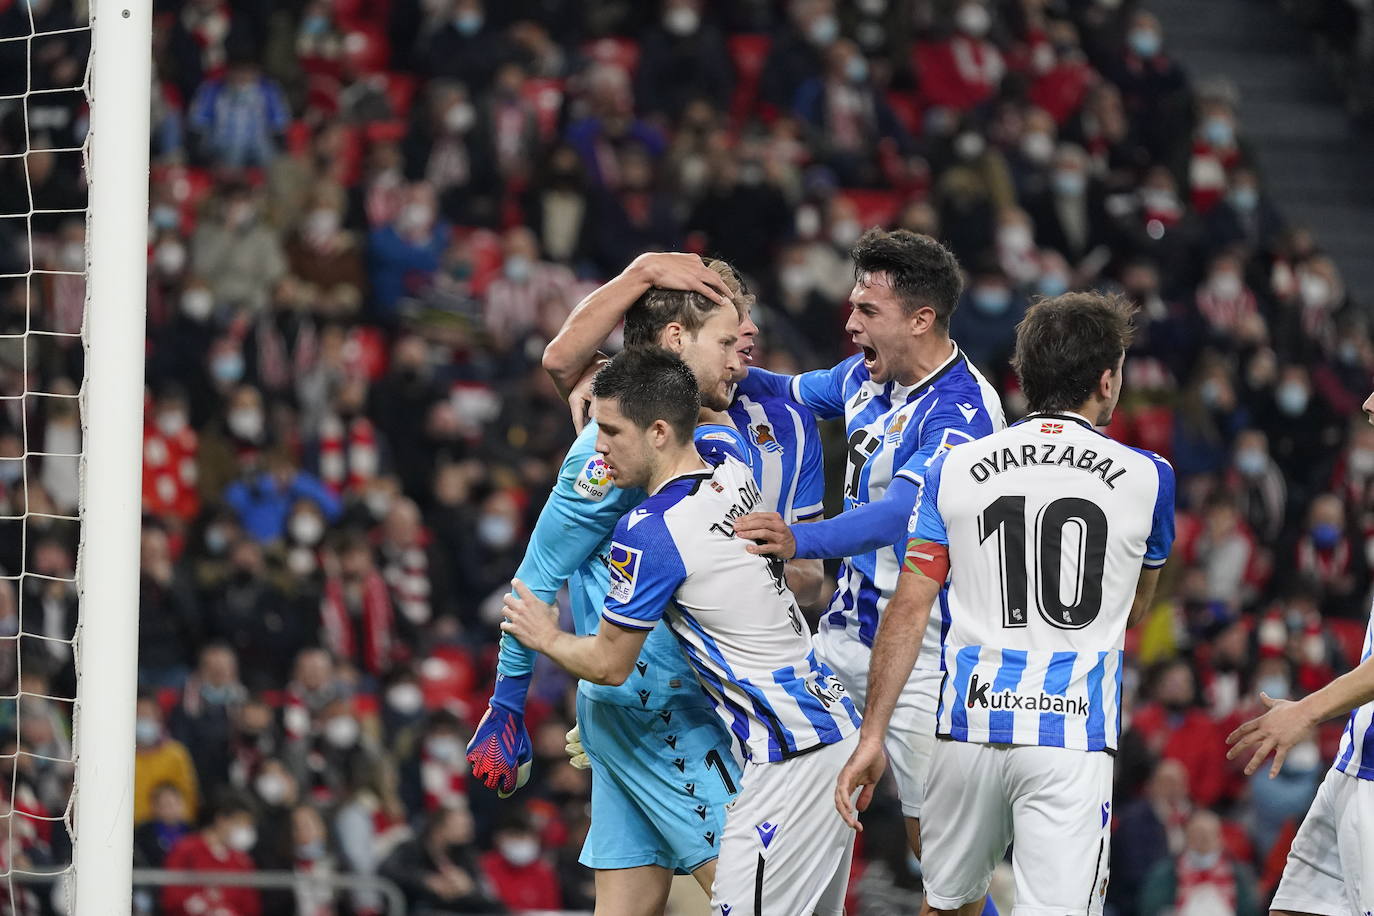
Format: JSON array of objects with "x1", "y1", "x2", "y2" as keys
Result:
[{"x1": 735, "y1": 229, "x2": 1004, "y2": 856}]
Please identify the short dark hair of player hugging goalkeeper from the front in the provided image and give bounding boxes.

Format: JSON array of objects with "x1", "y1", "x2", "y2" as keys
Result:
[{"x1": 592, "y1": 346, "x2": 701, "y2": 444}]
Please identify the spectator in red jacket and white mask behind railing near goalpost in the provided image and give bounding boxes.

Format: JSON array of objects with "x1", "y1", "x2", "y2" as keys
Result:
[{"x1": 162, "y1": 791, "x2": 262, "y2": 916}]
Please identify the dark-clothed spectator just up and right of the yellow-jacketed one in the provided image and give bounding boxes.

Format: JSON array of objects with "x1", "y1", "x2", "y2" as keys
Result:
[{"x1": 169, "y1": 643, "x2": 247, "y2": 786}]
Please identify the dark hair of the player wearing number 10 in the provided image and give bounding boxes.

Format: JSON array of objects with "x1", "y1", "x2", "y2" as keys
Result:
[{"x1": 1011, "y1": 293, "x2": 1135, "y2": 411}]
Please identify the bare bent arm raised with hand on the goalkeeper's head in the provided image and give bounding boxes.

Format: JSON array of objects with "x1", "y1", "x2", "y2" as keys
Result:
[{"x1": 544, "y1": 251, "x2": 731, "y2": 397}]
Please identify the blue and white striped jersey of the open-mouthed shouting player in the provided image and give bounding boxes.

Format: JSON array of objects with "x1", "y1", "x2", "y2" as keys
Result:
[{"x1": 741, "y1": 346, "x2": 1006, "y2": 669}]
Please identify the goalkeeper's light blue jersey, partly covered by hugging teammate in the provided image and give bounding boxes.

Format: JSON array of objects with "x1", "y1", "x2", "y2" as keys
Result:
[{"x1": 496, "y1": 422, "x2": 746, "y2": 709}]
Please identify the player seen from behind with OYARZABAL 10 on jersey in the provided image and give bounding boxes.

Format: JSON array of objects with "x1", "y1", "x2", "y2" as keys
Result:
[{"x1": 835, "y1": 293, "x2": 1173, "y2": 915}]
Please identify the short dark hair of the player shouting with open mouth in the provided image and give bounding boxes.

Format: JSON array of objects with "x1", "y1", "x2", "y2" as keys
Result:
[{"x1": 849, "y1": 227, "x2": 963, "y2": 334}]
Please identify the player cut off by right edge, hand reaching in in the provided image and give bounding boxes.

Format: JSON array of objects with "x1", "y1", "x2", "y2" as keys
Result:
[{"x1": 1226, "y1": 384, "x2": 1374, "y2": 916}]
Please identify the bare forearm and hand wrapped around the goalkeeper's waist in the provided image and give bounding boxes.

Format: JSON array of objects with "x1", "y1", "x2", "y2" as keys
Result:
[{"x1": 502, "y1": 580, "x2": 653, "y2": 685}]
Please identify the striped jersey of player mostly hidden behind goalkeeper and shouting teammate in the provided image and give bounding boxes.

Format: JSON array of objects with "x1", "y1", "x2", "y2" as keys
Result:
[{"x1": 728, "y1": 394, "x2": 826, "y2": 525}]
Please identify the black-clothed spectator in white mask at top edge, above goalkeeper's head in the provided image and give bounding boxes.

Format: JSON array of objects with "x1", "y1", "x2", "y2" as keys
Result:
[{"x1": 635, "y1": 0, "x2": 734, "y2": 119}]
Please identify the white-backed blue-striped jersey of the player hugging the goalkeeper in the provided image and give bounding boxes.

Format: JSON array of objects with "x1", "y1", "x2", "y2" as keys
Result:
[{"x1": 602, "y1": 457, "x2": 860, "y2": 762}]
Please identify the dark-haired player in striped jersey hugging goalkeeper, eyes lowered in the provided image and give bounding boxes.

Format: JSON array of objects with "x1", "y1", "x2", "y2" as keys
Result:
[{"x1": 502, "y1": 350, "x2": 859, "y2": 916}]
